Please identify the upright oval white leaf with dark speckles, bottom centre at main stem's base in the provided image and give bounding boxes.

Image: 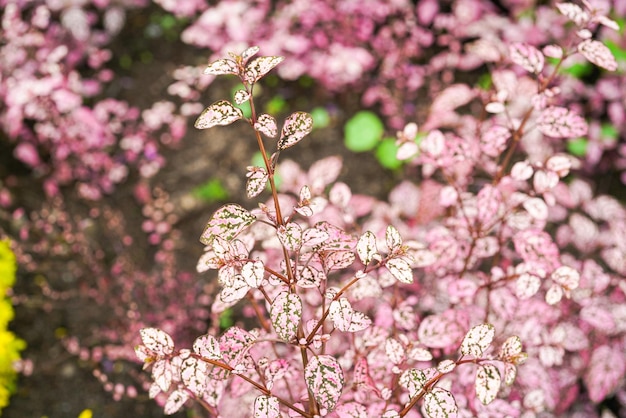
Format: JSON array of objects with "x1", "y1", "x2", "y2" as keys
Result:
[{"x1": 304, "y1": 355, "x2": 344, "y2": 412}]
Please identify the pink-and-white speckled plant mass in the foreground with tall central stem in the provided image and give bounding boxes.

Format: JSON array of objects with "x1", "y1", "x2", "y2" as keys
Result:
[{"x1": 135, "y1": 2, "x2": 626, "y2": 417}]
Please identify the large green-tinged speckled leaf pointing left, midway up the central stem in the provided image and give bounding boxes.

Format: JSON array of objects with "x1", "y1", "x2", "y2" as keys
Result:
[{"x1": 200, "y1": 203, "x2": 256, "y2": 245}]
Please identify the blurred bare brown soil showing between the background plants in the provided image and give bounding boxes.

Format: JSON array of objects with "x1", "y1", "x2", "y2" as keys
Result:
[{"x1": 2, "y1": 7, "x2": 395, "y2": 418}]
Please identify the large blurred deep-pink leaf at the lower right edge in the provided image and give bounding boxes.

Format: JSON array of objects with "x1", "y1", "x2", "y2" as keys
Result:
[{"x1": 584, "y1": 345, "x2": 626, "y2": 403}]
